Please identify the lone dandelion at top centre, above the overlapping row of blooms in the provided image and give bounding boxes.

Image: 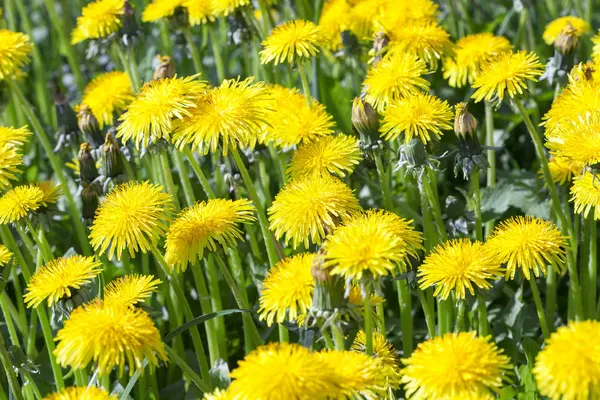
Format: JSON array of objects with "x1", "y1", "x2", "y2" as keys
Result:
[{"x1": 260, "y1": 20, "x2": 323, "y2": 65}]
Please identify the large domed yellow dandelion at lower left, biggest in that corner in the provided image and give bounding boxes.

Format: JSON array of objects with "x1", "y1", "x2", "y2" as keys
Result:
[{"x1": 54, "y1": 301, "x2": 167, "y2": 376}]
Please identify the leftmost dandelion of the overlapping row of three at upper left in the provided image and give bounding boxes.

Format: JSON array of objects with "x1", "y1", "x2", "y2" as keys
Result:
[{"x1": 117, "y1": 75, "x2": 206, "y2": 147}]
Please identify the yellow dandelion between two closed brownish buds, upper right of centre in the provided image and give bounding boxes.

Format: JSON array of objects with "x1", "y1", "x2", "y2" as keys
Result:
[{"x1": 380, "y1": 93, "x2": 454, "y2": 143}]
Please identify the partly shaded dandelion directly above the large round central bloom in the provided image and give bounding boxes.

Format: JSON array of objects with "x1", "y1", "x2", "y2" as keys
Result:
[{"x1": 288, "y1": 135, "x2": 361, "y2": 178}]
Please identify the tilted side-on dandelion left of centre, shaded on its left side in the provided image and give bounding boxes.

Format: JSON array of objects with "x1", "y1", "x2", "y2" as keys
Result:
[{"x1": 165, "y1": 199, "x2": 255, "y2": 271}]
